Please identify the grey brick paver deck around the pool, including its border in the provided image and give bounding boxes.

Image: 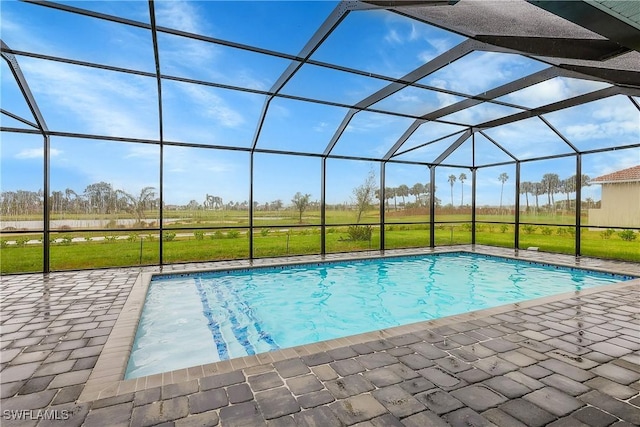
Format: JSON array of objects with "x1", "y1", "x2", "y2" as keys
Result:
[{"x1": 0, "y1": 246, "x2": 640, "y2": 427}]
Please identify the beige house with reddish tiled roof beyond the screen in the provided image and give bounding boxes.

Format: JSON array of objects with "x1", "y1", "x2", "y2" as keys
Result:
[{"x1": 589, "y1": 165, "x2": 640, "y2": 227}]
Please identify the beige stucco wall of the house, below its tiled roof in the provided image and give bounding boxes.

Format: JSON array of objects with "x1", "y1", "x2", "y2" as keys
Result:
[{"x1": 589, "y1": 182, "x2": 640, "y2": 227}]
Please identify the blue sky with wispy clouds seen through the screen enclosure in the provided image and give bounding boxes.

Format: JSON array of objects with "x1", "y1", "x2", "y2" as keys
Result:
[{"x1": 0, "y1": 1, "x2": 640, "y2": 204}]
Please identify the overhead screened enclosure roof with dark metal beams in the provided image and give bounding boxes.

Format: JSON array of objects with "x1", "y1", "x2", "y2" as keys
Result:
[{"x1": 2, "y1": 0, "x2": 640, "y2": 167}]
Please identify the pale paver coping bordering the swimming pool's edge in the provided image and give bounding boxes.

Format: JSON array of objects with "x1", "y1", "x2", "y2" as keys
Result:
[{"x1": 78, "y1": 246, "x2": 640, "y2": 402}]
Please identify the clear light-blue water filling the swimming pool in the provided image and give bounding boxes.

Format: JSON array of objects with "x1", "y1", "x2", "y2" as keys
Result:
[{"x1": 125, "y1": 252, "x2": 633, "y2": 378}]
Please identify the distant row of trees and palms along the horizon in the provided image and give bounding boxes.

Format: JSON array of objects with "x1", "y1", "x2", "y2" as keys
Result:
[{"x1": 0, "y1": 172, "x2": 590, "y2": 221}]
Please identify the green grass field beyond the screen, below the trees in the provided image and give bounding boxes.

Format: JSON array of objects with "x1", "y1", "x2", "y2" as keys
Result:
[{"x1": 0, "y1": 211, "x2": 640, "y2": 274}]
